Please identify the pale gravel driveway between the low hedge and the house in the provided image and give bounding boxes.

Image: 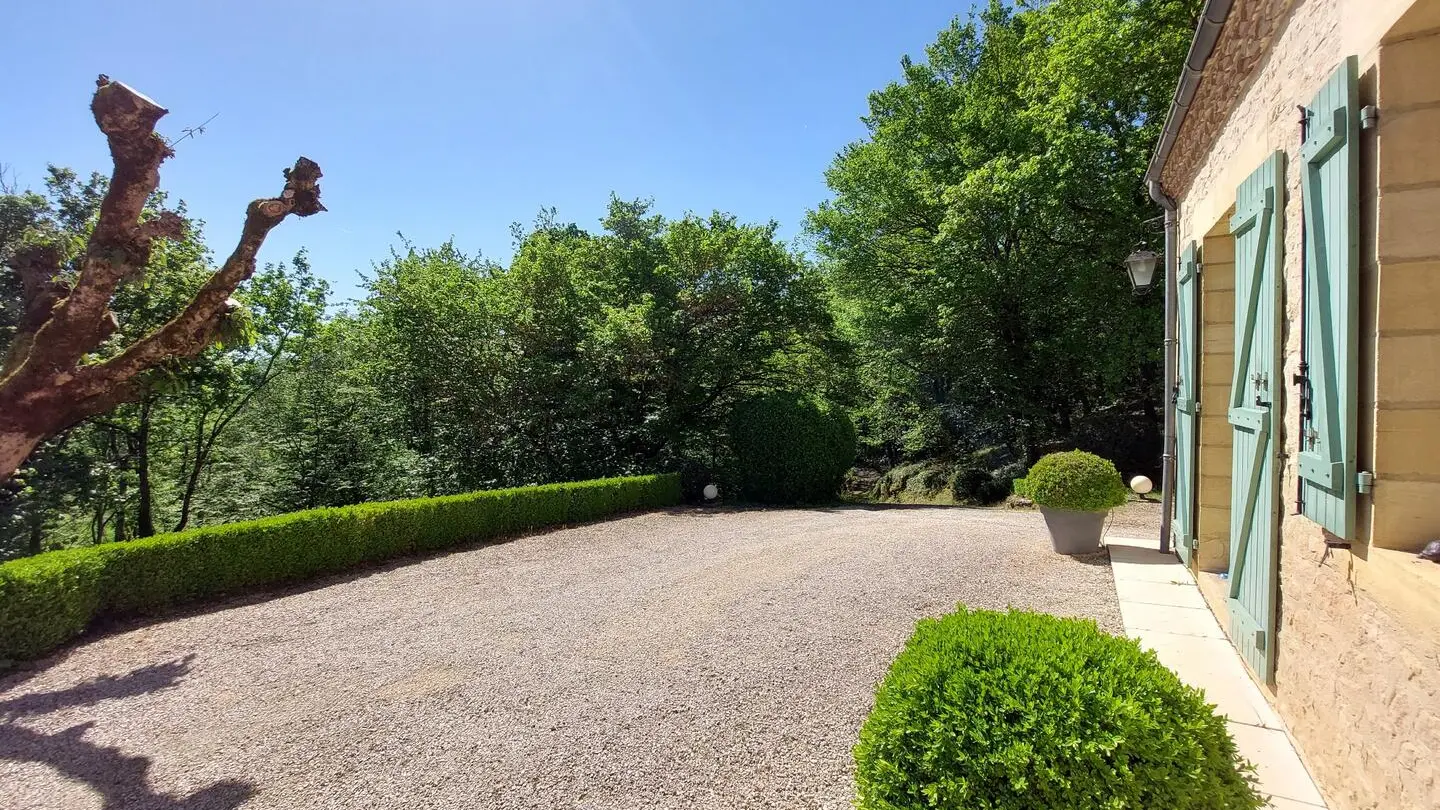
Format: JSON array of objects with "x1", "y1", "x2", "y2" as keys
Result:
[{"x1": 0, "y1": 507, "x2": 1120, "y2": 810}]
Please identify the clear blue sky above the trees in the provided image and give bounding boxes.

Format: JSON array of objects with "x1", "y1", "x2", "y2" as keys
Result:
[{"x1": 0, "y1": 0, "x2": 968, "y2": 300}]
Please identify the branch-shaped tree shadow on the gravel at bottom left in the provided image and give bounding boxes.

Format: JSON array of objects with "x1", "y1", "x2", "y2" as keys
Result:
[{"x1": 0, "y1": 654, "x2": 256, "y2": 810}]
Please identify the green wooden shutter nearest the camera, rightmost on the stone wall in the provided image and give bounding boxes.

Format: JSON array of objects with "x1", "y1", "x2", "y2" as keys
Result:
[{"x1": 1297, "y1": 56, "x2": 1359, "y2": 539}]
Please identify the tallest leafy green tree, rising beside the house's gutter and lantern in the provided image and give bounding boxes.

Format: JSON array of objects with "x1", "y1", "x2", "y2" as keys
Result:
[{"x1": 809, "y1": 0, "x2": 1198, "y2": 466}]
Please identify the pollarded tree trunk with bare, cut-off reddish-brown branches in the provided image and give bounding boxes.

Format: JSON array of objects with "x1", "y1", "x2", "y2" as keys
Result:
[{"x1": 0, "y1": 75, "x2": 325, "y2": 481}]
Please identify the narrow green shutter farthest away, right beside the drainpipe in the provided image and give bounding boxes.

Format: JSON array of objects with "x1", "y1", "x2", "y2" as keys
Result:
[{"x1": 1171, "y1": 242, "x2": 1200, "y2": 562}]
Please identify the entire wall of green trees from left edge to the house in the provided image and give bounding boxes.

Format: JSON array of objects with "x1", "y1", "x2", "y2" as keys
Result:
[{"x1": 0, "y1": 0, "x2": 1200, "y2": 556}]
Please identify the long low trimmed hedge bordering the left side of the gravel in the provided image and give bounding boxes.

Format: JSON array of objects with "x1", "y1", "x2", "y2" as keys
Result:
[{"x1": 0, "y1": 474, "x2": 680, "y2": 659}]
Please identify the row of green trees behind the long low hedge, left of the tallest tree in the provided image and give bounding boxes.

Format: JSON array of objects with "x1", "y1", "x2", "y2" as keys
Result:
[{"x1": 0, "y1": 194, "x2": 845, "y2": 553}]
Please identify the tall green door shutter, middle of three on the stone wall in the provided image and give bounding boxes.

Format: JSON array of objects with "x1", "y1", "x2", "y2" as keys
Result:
[{"x1": 1228, "y1": 151, "x2": 1284, "y2": 682}]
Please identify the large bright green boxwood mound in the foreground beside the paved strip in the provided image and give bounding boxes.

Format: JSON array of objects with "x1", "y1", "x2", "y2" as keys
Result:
[{"x1": 855, "y1": 608, "x2": 1263, "y2": 810}]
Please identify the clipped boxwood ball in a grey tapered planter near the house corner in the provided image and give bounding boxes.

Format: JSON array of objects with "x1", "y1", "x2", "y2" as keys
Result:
[{"x1": 1015, "y1": 450, "x2": 1126, "y2": 553}]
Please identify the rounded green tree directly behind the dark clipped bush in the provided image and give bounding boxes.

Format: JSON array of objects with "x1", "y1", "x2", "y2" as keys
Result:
[{"x1": 504, "y1": 199, "x2": 835, "y2": 490}]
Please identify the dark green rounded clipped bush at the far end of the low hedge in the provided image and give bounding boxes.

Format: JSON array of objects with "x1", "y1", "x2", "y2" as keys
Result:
[{"x1": 730, "y1": 392, "x2": 855, "y2": 503}]
